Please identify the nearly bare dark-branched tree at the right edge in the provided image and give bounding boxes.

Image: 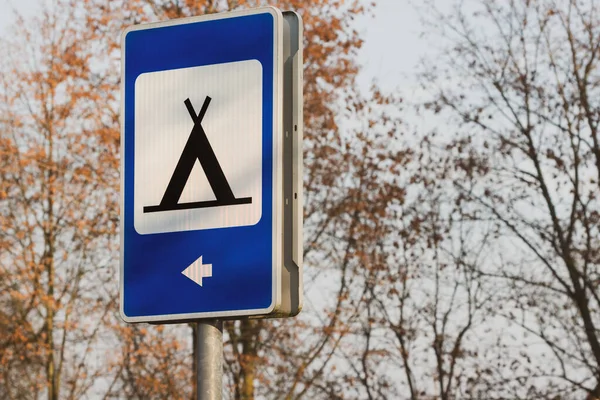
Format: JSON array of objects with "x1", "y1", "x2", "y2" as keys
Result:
[{"x1": 423, "y1": 0, "x2": 600, "y2": 399}]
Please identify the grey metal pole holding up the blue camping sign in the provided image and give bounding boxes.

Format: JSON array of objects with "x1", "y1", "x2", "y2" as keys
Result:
[{"x1": 194, "y1": 320, "x2": 223, "y2": 400}]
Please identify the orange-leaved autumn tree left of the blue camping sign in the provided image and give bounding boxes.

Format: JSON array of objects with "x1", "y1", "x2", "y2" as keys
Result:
[{"x1": 0, "y1": 1, "x2": 119, "y2": 399}]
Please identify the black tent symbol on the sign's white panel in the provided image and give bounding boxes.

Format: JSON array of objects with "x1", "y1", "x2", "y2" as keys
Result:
[{"x1": 144, "y1": 96, "x2": 252, "y2": 213}]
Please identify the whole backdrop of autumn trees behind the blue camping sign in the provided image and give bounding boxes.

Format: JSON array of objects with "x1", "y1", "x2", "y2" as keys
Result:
[{"x1": 0, "y1": 0, "x2": 600, "y2": 399}]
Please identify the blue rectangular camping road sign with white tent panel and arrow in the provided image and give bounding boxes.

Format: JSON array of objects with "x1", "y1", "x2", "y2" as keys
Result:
[{"x1": 120, "y1": 7, "x2": 302, "y2": 323}]
